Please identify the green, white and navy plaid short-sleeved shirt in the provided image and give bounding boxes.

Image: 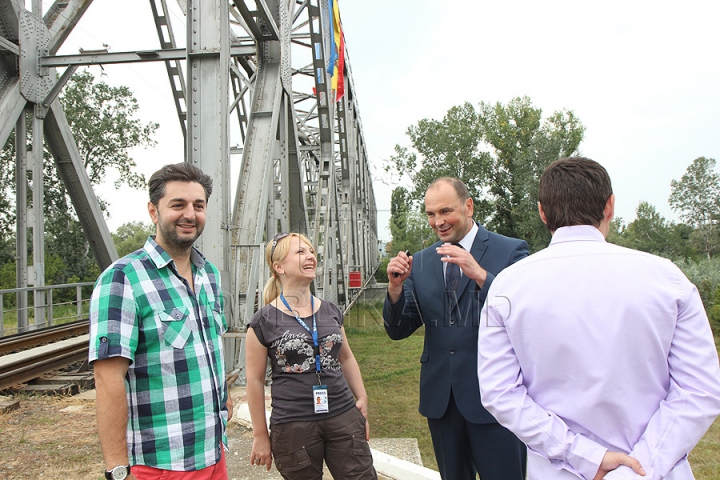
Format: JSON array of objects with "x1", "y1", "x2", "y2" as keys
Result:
[{"x1": 89, "y1": 237, "x2": 228, "y2": 471}]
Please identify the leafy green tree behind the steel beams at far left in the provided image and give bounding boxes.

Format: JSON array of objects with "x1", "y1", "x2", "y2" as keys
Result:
[{"x1": 0, "y1": 71, "x2": 158, "y2": 280}]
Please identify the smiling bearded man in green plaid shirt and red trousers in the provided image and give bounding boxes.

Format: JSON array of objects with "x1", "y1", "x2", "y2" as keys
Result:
[{"x1": 89, "y1": 163, "x2": 232, "y2": 480}]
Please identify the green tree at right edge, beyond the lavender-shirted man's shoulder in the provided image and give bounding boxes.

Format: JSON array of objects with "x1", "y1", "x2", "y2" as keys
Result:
[{"x1": 669, "y1": 157, "x2": 720, "y2": 258}]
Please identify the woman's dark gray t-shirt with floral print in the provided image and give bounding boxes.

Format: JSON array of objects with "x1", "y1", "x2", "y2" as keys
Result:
[{"x1": 248, "y1": 300, "x2": 355, "y2": 424}]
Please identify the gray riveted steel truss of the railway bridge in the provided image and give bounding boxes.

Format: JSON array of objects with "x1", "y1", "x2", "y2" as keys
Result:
[{"x1": 0, "y1": 0, "x2": 378, "y2": 374}]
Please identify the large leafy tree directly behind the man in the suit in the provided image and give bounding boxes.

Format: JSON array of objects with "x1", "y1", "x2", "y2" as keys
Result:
[{"x1": 387, "y1": 97, "x2": 585, "y2": 251}]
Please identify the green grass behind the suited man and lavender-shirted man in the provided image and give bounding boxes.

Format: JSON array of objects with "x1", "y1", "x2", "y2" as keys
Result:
[{"x1": 345, "y1": 303, "x2": 720, "y2": 480}]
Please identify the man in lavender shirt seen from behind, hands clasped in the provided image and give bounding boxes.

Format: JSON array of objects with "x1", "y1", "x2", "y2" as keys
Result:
[{"x1": 478, "y1": 158, "x2": 720, "y2": 480}]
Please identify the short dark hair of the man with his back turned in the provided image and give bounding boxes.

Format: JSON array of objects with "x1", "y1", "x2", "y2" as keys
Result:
[{"x1": 539, "y1": 157, "x2": 612, "y2": 232}]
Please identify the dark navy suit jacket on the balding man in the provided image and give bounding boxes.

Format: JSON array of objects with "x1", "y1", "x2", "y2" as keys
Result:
[{"x1": 383, "y1": 225, "x2": 528, "y2": 423}]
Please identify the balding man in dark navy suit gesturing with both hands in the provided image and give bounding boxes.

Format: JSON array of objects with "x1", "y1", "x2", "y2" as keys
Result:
[{"x1": 383, "y1": 177, "x2": 528, "y2": 480}]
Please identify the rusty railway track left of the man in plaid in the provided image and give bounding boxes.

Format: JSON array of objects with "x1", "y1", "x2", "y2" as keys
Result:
[{"x1": 0, "y1": 320, "x2": 89, "y2": 390}]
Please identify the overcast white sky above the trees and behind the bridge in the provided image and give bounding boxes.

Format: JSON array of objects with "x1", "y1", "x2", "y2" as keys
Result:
[{"x1": 48, "y1": 0, "x2": 720, "y2": 240}]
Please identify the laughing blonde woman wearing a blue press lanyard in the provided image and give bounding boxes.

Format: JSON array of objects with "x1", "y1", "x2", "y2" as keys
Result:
[{"x1": 245, "y1": 233, "x2": 377, "y2": 480}]
